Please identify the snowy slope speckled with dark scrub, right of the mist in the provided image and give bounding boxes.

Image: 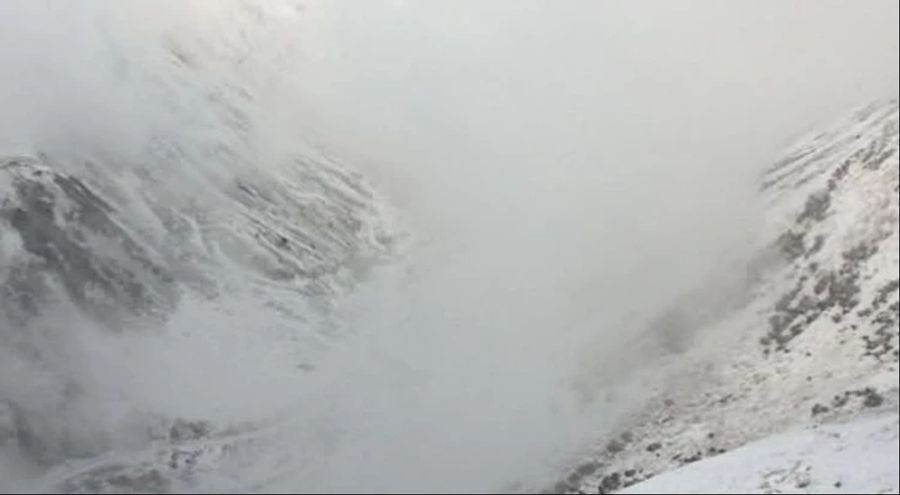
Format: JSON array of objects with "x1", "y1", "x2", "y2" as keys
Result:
[{"x1": 554, "y1": 100, "x2": 900, "y2": 493}]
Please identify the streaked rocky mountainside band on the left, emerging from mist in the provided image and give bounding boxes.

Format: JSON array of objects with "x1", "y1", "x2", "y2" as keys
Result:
[{"x1": 0, "y1": 151, "x2": 389, "y2": 330}]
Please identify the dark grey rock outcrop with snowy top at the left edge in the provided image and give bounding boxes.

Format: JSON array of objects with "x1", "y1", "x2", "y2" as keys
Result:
[{"x1": 0, "y1": 159, "x2": 179, "y2": 326}]
